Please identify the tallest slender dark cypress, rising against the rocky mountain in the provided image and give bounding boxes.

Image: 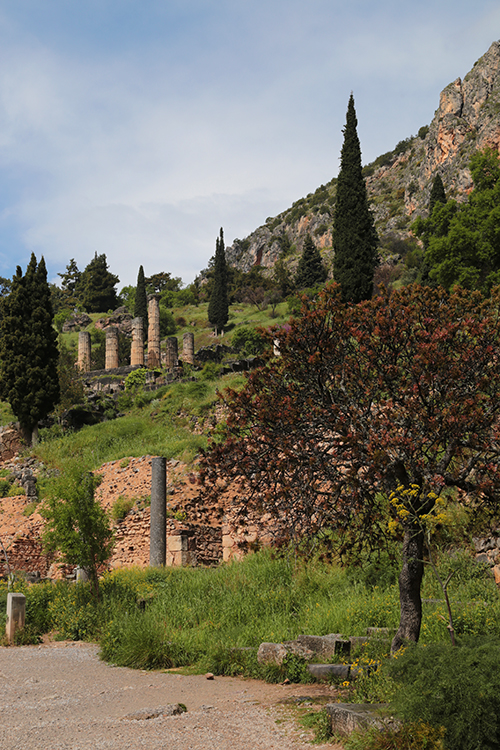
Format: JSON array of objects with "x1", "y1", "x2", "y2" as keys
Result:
[{"x1": 333, "y1": 94, "x2": 378, "y2": 302}]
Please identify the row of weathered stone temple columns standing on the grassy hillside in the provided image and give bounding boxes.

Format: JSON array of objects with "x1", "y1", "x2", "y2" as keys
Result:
[{"x1": 77, "y1": 296, "x2": 194, "y2": 372}]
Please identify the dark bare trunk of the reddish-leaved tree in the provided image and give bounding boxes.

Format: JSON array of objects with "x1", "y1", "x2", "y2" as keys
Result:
[{"x1": 391, "y1": 527, "x2": 424, "y2": 653}]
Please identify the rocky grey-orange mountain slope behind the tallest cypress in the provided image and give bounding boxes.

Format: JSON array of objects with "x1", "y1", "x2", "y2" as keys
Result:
[{"x1": 226, "y1": 42, "x2": 500, "y2": 280}]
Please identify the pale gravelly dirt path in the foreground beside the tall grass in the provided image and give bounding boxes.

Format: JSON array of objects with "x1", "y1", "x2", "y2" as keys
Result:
[{"x1": 0, "y1": 643, "x2": 344, "y2": 750}]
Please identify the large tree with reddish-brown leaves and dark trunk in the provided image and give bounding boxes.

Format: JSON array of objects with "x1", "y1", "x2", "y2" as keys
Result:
[{"x1": 203, "y1": 285, "x2": 500, "y2": 650}]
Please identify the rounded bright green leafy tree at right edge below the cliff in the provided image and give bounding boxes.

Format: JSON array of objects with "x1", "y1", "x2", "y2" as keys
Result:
[{"x1": 413, "y1": 149, "x2": 500, "y2": 294}]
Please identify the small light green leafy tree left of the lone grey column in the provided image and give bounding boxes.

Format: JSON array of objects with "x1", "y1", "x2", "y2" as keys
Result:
[{"x1": 43, "y1": 465, "x2": 113, "y2": 599}]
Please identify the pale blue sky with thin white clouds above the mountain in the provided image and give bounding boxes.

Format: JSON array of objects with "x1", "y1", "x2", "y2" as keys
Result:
[{"x1": 0, "y1": 0, "x2": 500, "y2": 290}]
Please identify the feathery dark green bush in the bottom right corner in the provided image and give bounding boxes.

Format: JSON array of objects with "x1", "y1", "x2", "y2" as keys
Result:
[{"x1": 388, "y1": 642, "x2": 500, "y2": 750}]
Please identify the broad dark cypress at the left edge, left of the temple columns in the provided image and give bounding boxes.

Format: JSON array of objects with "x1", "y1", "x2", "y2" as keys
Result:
[{"x1": 0, "y1": 255, "x2": 59, "y2": 443}]
